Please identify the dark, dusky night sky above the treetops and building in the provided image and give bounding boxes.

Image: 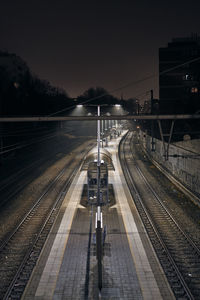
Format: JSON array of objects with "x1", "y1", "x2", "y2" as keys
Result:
[{"x1": 0, "y1": 0, "x2": 200, "y2": 99}]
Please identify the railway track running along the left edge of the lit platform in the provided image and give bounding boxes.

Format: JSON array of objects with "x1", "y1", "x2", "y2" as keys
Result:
[{"x1": 0, "y1": 146, "x2": 91, "y2": 300}]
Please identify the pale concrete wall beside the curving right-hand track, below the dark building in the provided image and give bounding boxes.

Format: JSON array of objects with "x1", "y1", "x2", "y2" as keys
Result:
[{"x1": 139, "y1": 132, "x2": 200, "y2": 197}]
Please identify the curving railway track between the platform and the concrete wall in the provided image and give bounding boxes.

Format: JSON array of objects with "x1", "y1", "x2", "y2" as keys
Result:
[{"x1": 120, "y1": 133, "x2": 200, "y2": 299}]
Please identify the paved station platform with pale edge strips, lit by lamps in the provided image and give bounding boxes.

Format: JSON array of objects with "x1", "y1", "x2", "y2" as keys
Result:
[{"x1": 22, "y1": 132, "x2": 174, "y2": 300}]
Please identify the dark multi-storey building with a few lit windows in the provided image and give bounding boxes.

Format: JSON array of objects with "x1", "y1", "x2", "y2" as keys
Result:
[{"x1": 159, "y1": 35, "x2": 200, "y2": 114}]
